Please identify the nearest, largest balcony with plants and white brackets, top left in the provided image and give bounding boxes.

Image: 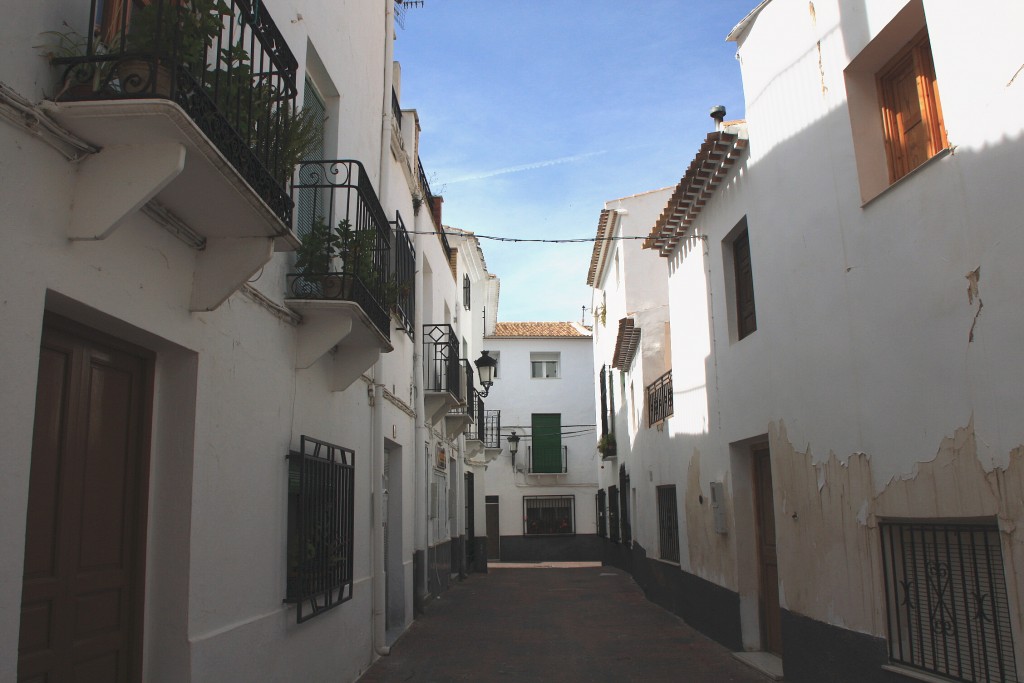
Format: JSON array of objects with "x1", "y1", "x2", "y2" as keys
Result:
[{"x1": 45, "y1": 0, "x2": 299, "y2": 310}]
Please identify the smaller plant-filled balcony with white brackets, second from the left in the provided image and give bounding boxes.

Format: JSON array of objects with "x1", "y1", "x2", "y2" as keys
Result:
[{"x1": 286, "y1": 160, "x2": 397, "y2": 391}]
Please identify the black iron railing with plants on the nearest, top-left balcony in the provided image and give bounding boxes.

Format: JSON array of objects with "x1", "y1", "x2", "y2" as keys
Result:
[{"x1": 50, "y1": 0, "x2": 299, "y2": 225}]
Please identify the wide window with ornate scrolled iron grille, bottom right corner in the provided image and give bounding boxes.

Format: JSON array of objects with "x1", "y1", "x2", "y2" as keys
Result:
[{"x1": 881, "y1": 521, "x2": 1019, "y2": 683}]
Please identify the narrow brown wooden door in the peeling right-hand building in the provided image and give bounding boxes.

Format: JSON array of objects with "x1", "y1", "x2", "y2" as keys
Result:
[{"x1": 754, "y1": 445, "x2": 782, "y2": 654}]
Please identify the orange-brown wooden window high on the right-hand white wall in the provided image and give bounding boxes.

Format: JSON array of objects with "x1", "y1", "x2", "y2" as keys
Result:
[{"x1": 878, "y1": 30, "x2": 947, "y2": 182}]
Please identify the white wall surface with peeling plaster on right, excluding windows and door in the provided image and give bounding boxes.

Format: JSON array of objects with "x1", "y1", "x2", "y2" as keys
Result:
[{"x1": 647, "y1": 0, "x2": 1024, "y2": 660}]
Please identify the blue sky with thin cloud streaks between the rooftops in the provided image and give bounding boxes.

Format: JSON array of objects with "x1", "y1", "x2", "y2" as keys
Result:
[{"x1": 395, "y1": 0, "x2": 757, "y2": 325}]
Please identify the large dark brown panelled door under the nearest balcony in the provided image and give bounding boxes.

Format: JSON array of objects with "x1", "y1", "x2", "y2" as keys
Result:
[{"x1": 18, "y1": 318, "x2": 152, "y2": 683}]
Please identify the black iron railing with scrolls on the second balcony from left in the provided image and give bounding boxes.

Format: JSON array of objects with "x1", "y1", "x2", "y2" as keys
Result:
[{"x1": 288, "y1": 160, "x2": 395, "y2": 339}]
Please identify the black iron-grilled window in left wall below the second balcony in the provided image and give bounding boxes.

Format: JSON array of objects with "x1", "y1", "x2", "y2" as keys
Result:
[{"x1": 285, "y1": 435, "x2": 355, "y2": 624}]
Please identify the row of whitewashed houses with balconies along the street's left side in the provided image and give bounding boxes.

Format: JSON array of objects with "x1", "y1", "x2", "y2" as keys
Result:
[{"x1": 0, "y1": 0, "x2": 495, "y2": 683}]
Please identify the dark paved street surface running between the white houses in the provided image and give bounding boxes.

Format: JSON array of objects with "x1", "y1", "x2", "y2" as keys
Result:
[{"x1": 359, "y1": 567, "x2": 769, "y2": 683}]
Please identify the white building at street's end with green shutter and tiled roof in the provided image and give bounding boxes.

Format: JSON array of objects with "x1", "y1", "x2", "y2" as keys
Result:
[{"x1": 483, "y1": 323, "x2": 601, "y2": 562}]
